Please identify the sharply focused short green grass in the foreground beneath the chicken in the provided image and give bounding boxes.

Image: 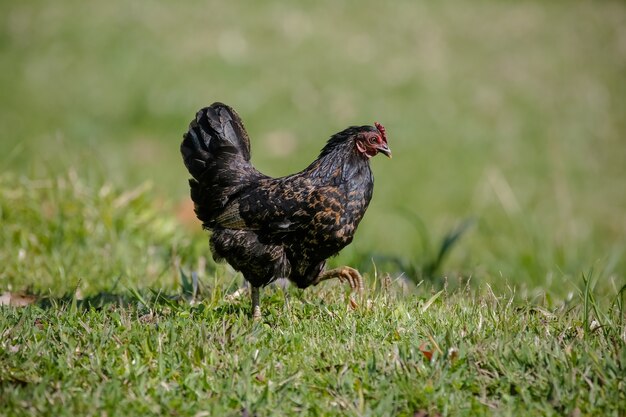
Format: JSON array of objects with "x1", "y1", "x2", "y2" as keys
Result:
[{"x1": 0, "y1": 270, "x2": 626, "y2": 416}]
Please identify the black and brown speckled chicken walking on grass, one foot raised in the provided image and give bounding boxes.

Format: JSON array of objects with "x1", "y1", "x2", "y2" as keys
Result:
[{"x1": 180, "y1": 103, "x2": 391, "y2": 318}]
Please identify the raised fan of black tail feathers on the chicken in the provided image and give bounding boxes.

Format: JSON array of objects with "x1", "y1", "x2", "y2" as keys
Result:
[{"x1": 180, "y1": 103, "x2": 263, "y2": 227}]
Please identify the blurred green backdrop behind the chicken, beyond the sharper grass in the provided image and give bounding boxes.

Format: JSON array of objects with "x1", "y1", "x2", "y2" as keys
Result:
[{"x1": 0, "y1": 0, "x2": 626, "y2": 296}]
